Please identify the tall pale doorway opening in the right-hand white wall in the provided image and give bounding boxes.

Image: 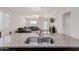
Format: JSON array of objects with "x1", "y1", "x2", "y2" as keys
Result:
[{"x1": 62, "y1": 12, "x2": 71, "y2": 36}]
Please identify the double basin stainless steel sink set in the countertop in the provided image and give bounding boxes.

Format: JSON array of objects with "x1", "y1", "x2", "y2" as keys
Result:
[{"x1": 25, "y1": 37, "x2": 54, "y2": 44}]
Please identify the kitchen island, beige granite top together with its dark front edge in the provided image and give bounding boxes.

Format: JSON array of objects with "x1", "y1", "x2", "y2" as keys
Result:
[{"x1": 0, "y1": 33, "x2": 79, "y2": 50}]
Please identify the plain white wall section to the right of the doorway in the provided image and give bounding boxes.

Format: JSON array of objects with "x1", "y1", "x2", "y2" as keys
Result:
[{"x1": 71, "y1": 8, "x2": 79, "y2": 39}]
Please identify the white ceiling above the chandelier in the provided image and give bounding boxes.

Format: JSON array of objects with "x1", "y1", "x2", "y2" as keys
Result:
[{"x1": 8, "y1": 7, "x2": 60, "y2": 16}]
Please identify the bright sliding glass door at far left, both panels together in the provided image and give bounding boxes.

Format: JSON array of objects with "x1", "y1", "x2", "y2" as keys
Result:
[{"x1": 0, "y1": 13, "x2": 10, "y2": 46}]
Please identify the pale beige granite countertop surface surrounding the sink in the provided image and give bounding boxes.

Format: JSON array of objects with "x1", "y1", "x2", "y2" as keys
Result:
[{"x1": 0, "y1": 33, "x2": 79, "y2": 48}]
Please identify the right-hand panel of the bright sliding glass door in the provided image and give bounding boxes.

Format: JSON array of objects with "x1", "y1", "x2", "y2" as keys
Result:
[{"x1": 3, "y1": 14, "x2": 10, "y2": 46}]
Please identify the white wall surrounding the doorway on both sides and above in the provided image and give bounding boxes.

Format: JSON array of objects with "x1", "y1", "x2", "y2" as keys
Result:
[{"x1": 56, "y1": 7, "x2": 79, "y2": 39}]
